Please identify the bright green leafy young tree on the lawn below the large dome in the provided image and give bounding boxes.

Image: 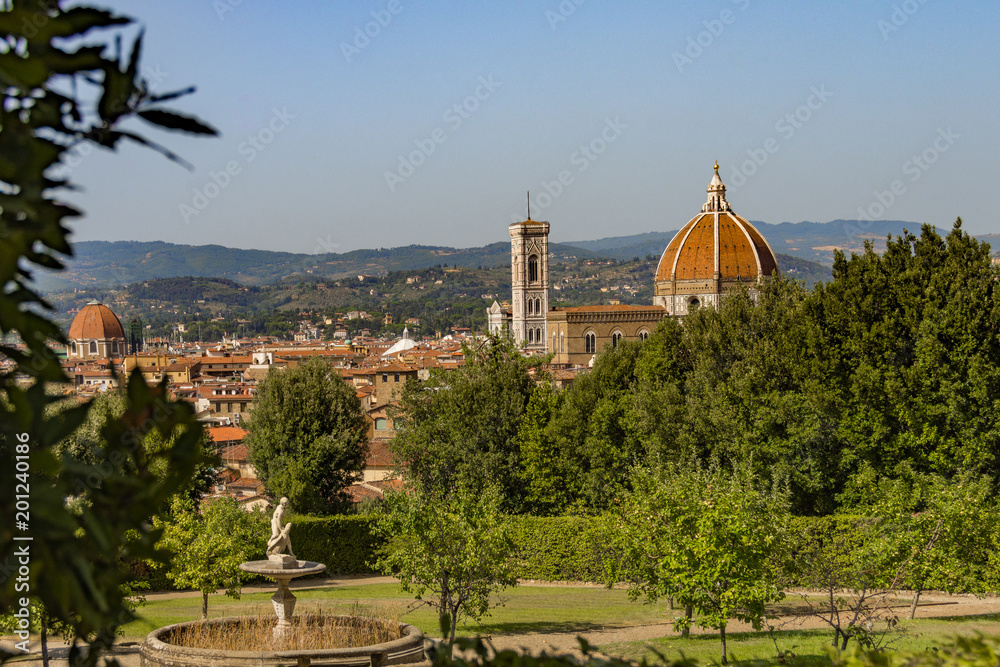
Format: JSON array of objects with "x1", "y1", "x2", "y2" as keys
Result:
[{"x1": 610, "y1": 465, "x2": 789, "y2": 664}]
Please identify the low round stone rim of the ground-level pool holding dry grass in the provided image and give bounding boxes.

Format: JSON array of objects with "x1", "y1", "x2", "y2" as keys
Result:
[{"x1": 139, "y1": 616, "x2": 430, "y2": 667}]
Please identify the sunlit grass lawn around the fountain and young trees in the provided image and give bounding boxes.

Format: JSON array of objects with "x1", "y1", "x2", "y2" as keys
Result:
[{"x1": 125, "y1": 583, "x2": 1000, "y2": 665}]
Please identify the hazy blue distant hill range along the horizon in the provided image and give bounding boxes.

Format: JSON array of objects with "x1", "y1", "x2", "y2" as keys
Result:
[{"x1": 38, "y1": 220, "x2": 972, "y2": 293}]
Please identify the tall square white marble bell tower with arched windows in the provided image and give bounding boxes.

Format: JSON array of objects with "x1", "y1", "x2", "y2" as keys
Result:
[{"x1": 509, "y1": 217, "x2": 549, "y2": 353}]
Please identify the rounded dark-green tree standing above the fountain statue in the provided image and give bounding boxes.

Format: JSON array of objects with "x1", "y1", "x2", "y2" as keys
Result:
[{"x1": 245, "y1": 357, "x2": 368, "y2": 514}]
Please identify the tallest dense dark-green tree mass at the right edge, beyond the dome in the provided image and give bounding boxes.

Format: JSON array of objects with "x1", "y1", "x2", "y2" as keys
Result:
[{"x1": 808, "y1": 219, "x2": 1000, "y2": 488}]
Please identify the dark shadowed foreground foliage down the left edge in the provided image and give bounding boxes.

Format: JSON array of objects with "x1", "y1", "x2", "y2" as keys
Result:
[{"x1": 0, "y1": 0, "x2": 216, "y2": 664}]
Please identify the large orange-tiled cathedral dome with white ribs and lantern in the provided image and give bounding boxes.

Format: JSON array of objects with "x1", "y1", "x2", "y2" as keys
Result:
[{"x1": 653, "y1": 163, "x2": 778, "y2": 315}]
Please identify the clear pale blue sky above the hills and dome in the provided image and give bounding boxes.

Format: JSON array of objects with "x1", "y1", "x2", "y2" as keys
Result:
[{"x1": 60, "y1": 0, "x2": 1000, "y2": 253}]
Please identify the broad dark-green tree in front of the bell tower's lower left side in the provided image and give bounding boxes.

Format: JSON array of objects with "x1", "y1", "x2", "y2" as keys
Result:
[{"x1": 389, "y1": 336, "x2": 538, "y2": 511}]
